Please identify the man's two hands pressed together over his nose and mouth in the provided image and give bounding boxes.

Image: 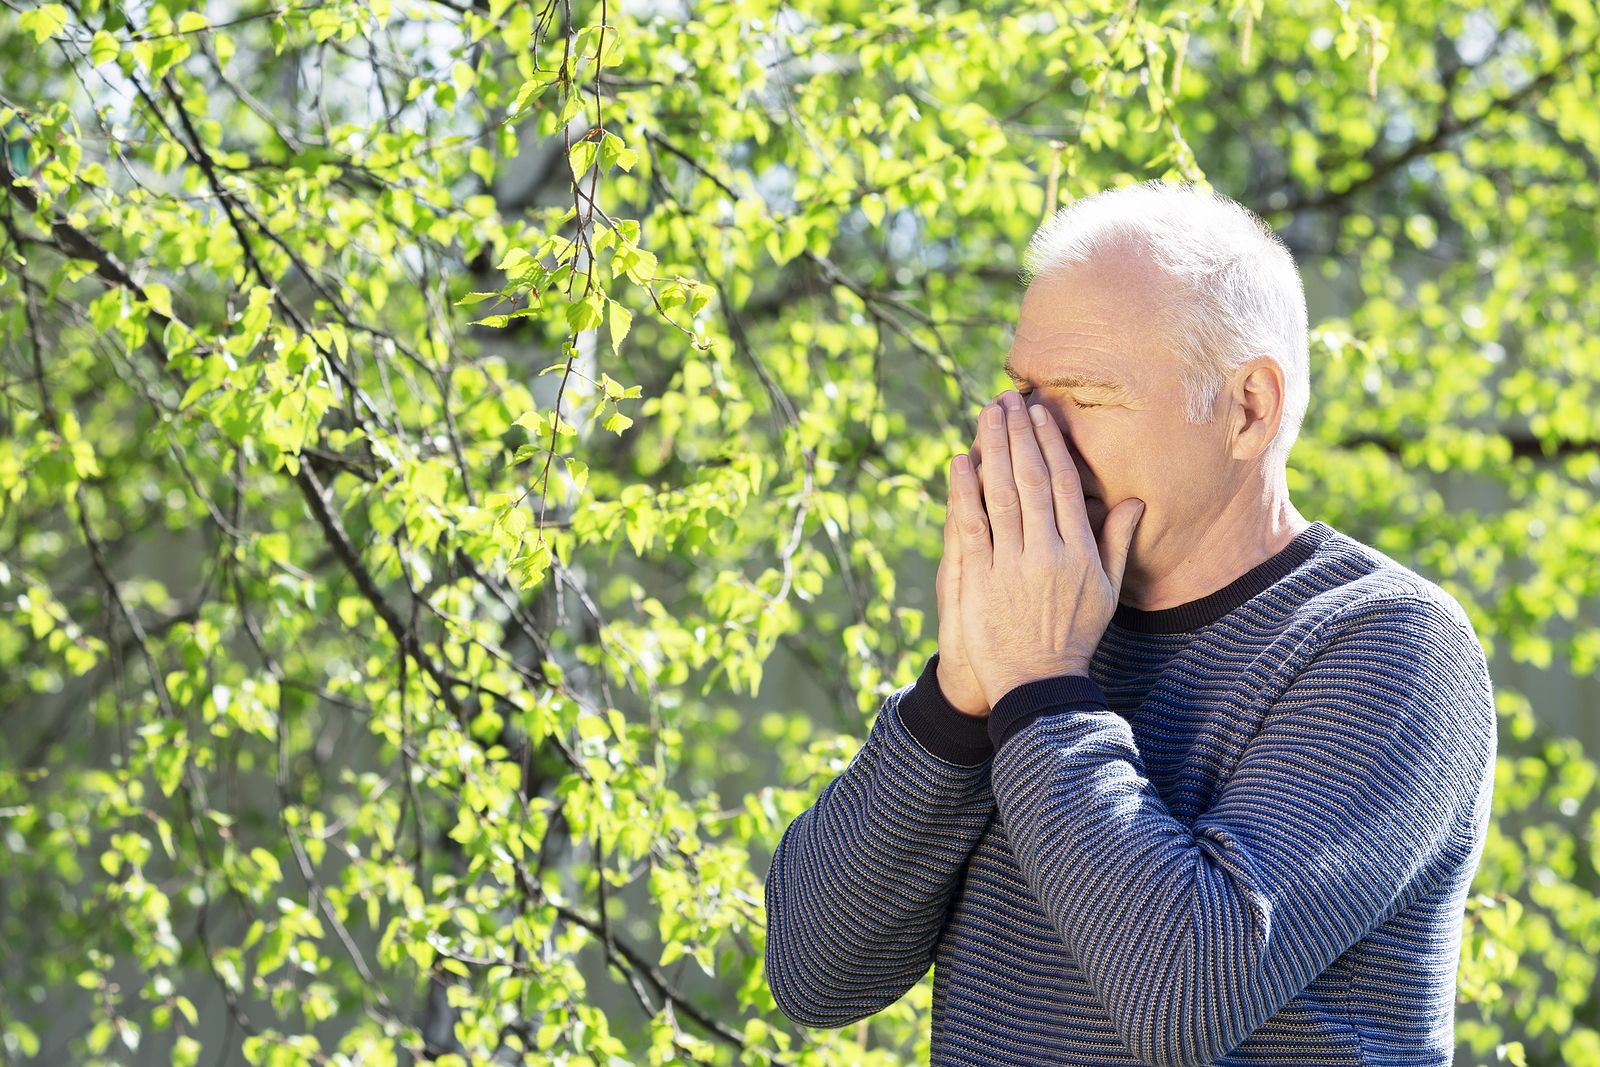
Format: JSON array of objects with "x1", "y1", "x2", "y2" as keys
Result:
[{"x1": 941, "y1": 390, "x2": 1144, "y2": 707}]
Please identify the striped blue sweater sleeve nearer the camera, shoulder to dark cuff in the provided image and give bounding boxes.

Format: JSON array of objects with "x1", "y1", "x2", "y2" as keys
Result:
[{"x1": 989, "y1": 595, "x2": 1496, "y2": 1067}]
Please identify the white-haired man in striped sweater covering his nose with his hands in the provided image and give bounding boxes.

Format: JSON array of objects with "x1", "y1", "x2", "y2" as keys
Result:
[{"x1": 766, "y1": 182, "x2": 1496, "y2": 1067}]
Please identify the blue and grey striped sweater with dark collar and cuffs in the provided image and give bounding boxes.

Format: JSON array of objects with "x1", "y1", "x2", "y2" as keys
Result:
[{"x1": 765, "y1": 522, "x2": 1496, "y2": 1067}]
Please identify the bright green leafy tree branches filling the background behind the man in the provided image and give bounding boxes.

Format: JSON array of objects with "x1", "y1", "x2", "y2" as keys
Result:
[{"x1": 0, "y1": 0, "x2": 1600, "y2": 1065}]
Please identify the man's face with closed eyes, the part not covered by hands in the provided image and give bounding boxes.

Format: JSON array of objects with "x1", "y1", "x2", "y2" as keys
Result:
[{"x1": 1006, "y1": 251, "x2": 1227, "y2": 552}]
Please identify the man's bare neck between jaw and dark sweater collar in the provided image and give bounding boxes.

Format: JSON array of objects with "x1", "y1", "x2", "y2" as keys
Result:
[{"x1": 1120, "y1": 472, "x2": 1310, "y2": 611}]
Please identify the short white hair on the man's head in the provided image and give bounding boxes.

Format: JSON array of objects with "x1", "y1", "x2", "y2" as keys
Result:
[{"x1": 1022, "y1": 179, "x2": 1310, "y2": 467}]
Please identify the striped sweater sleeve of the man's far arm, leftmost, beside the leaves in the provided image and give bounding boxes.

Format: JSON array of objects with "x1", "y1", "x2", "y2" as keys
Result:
[{"x1": 766, "y1": 654, "x2": 995, "y2": 1027}]
